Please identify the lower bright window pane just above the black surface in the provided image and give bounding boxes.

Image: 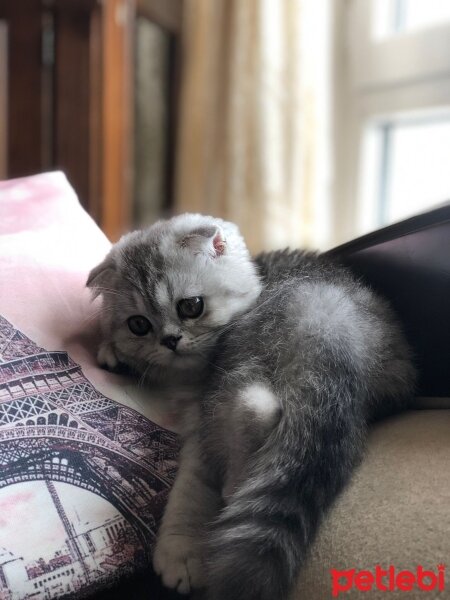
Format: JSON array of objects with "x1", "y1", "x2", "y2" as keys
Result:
[{"x1": 362, "y1": 114, "x2": 450, "y2": 229}]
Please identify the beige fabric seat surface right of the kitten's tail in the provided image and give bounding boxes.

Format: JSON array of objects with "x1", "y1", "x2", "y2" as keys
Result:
[{"x1": 296, "y1": 410, "x2": 450, "y2": 600}]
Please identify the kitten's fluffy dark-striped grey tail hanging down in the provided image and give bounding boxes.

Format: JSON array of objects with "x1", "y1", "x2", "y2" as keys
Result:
[{"x1": 207, "y1": 396, "x2": 365, "y2": 600}]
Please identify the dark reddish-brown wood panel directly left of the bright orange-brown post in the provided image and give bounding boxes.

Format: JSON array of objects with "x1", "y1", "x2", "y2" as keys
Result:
[{"x1": 54, "y1": 0, "x2": 103, "y2": 222}]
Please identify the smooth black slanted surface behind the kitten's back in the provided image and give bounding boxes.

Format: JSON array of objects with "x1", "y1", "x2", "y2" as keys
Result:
[{"x1": 328, "y1": 204, "x2": 450, "y2": 397}]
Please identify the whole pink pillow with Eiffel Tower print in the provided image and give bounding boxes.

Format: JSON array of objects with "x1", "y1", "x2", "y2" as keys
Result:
[{"x1": 0, "y1": 173, "x2": 179, "y2": 600}]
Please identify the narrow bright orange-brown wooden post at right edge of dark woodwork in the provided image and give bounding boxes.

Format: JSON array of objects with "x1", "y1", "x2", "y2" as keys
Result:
[{"x1": 100, "y1": 0, "x2": 134, "y2": 241}]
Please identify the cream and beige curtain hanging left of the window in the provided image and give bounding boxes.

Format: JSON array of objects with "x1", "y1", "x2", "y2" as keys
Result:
[{"x1": 176, "y1": 0, "x2": 331, "y2": 251}]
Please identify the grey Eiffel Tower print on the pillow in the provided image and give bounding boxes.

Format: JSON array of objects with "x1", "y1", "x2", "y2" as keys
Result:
[{"x1": 0, "y1": 316, "x2": 179, "y2": 600}]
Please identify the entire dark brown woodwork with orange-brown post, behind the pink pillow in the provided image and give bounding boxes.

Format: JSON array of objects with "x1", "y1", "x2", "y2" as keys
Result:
[{"x1": 0, "y1": 0, "x2": 135, "y2": 240}]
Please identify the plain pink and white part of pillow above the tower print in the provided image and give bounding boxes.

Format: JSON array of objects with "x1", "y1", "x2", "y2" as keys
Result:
[{"x1": 0, "y1": 172, "x2": 173, "y2": 428}]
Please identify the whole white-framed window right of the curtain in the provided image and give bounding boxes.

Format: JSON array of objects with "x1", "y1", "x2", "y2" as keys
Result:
[{"x1": 335, "y1": 0, "x2": 450, "y2": 242}]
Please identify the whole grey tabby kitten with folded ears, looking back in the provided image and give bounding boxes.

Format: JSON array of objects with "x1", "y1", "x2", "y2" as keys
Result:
[{"x1": 88, "y1": 215, "x2": 414, "y2": 600}]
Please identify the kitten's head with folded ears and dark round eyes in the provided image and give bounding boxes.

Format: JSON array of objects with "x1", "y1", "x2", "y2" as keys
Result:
[{"x1": 87, "y1": 214, "x2": 261, "y2": 379}]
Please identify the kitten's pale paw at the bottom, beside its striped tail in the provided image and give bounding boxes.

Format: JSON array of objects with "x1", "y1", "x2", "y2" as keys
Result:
[{"x1": 153, "y1": 534, "x2": 204, "y2": 594}]
